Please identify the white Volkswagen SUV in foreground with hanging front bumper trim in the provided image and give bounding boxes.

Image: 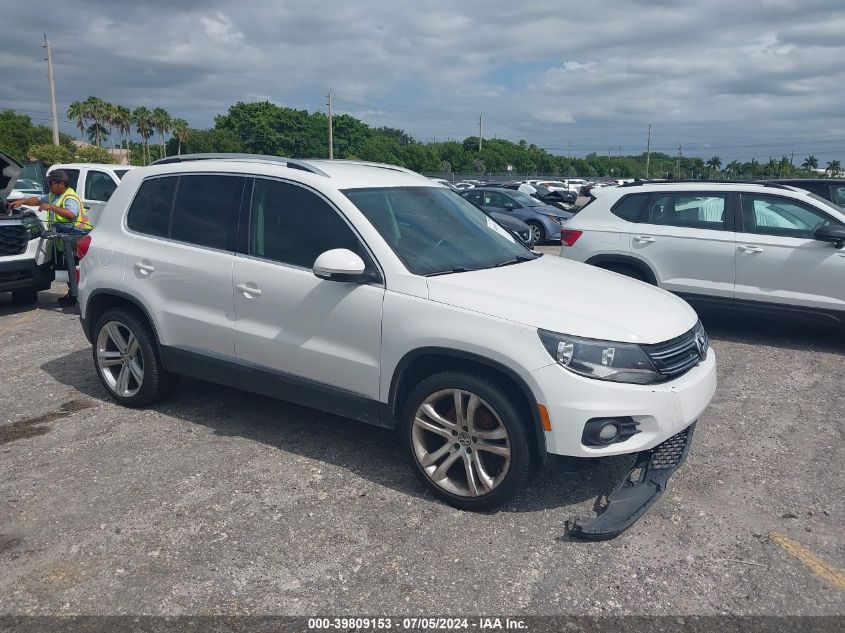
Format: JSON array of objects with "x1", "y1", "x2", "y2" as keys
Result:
[{"x1": 79, "y1": 155, "x2": 716, "y2": 538}]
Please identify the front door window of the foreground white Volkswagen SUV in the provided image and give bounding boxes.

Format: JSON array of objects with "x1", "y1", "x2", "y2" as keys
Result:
[{"x1": 249, "y1": 178, "x2": 358, "y2": 268}]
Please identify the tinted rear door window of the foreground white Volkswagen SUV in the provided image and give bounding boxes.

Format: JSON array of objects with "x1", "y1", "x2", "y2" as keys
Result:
[{"x1": 170, "y1": 174, "x2": 245, "y2": 251}]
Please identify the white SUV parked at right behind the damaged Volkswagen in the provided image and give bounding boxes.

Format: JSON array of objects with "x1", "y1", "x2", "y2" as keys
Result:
[{"x1": 560, "y1": 182, "x2": 845, "y2": 326}]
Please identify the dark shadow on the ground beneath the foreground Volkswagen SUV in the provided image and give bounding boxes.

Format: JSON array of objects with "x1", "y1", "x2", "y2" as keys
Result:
[{"x1": 41, "y1": 349, "x2": 633, "y2": 512}]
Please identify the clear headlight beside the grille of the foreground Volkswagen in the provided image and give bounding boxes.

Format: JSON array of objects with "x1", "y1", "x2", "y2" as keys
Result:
[{"x1": 537, "y1": 330, "x2": 666, "y2": 385}]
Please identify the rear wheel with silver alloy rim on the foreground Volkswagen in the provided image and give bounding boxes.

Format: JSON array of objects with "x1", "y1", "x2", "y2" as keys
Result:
[{"x1": 93, "y1": 308, "x2": 167, "y2": 408}]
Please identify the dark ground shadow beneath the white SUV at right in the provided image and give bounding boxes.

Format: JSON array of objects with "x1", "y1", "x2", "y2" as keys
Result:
[{"x1": 700, "y1": 312, "x2": 845, "y2": 354}]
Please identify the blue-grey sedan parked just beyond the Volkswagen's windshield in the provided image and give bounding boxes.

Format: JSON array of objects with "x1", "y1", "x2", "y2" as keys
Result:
[{"x1": 461, "y1": 187, "x2": 573, "y2": 244}]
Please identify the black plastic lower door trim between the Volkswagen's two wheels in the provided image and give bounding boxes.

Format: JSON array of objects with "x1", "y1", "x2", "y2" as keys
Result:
[{"x1": 161, "y1": 345, "x2": 386, "y2": 428}]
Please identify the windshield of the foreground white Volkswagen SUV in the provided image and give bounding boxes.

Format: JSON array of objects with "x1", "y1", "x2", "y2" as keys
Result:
[{"x1": 343, "y1": 187, "x2": 535, "y2": 275}]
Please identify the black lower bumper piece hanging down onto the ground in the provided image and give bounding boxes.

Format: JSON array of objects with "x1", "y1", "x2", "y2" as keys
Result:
[{"x1": 569, "y1": 423, "x2": 695, "y2": 541}]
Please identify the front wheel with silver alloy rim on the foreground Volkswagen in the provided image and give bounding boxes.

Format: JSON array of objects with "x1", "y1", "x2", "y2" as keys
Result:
[{"x1": 400, "y1": 371, "x2": 532, "y2": 510}]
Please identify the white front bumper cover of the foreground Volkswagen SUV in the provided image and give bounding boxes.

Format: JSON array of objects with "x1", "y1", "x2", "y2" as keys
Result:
[{"x1": 530, "y1": 348, "x2": 716, "y2": 457}]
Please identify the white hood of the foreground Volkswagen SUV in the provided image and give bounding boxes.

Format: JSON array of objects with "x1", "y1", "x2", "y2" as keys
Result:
[{"x1": 427, "y1": 255, "x2": 698, "y2": 344}]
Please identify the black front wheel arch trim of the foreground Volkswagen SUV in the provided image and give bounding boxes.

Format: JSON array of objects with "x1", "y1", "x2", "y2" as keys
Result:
[{"x1": 387, "y1": 347, "x2": 546, "y2": 462}]
